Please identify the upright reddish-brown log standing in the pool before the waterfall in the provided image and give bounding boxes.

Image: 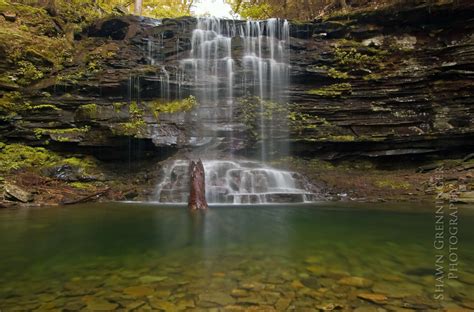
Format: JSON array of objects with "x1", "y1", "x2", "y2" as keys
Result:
[{"x1": 188, "y1": 159, "x2": 207, "y2": 210}]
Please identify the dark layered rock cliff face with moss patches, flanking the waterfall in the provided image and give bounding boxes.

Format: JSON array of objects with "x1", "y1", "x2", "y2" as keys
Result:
[{"x1": 0, "y1": 1, "x2": 474, "y2": 158}]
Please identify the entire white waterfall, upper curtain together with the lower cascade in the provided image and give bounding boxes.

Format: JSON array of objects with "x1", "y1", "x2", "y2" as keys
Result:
[{"x1": 150, "y1": 17, "x2": 315, "y2": 204}]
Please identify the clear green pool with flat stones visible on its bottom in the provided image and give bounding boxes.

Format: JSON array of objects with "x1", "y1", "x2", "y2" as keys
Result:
[{"x1": 0, "y1": 203, "x2": 474, "y2": 311}]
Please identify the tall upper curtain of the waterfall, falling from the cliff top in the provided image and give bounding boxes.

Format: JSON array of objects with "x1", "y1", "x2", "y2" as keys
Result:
[{"x1": 181, "y1": 18, "x2": 290, "y2": 161}]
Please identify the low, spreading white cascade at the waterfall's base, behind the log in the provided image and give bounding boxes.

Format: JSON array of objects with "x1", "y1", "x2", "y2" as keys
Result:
[{"x1": 156, "y1": 160, "x2": 315, "y2": 204}]
